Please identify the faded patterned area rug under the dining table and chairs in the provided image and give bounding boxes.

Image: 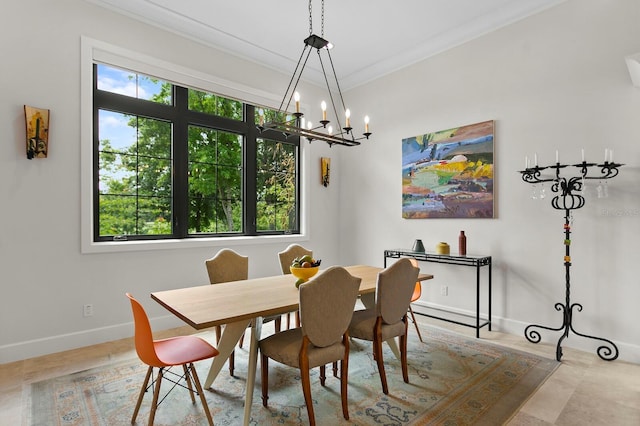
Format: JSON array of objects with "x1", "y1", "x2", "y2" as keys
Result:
[{"x1": 26, "y1": 327, "x2": 559, "y2": 426}]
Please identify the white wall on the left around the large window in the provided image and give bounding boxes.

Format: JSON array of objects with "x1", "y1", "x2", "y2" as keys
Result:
[{"x1": 0, "y1": 0, "x2": 340, "y2": 363}]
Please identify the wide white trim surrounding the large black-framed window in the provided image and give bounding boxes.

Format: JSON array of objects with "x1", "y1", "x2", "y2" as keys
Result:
[{"x1": 80, "y1": 36, "x2": 310, "y2": 253}]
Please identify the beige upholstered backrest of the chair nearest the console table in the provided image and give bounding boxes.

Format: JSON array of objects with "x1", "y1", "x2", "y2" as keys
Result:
[{"x1": 376, "y1": 258, "x2": 420, "y2": 324}]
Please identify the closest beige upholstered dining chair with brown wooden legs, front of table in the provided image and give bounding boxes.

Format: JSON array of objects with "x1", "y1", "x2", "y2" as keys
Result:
[{"x1": 260, "y1": 266, "x2": 361, "y2": 426}]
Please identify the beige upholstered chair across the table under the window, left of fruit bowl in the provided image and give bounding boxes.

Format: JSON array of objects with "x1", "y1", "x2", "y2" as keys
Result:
[{"x1": 204, "y1": 248, "x2": 280, "y2": 376}]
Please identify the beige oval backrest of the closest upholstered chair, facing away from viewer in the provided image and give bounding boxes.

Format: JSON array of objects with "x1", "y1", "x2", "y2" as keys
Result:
[{"x1": 300, "y1": 266, "x2": 362, "y2": 347}]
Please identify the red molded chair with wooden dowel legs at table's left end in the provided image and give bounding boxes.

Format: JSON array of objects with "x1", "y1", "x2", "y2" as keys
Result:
[{"x1": 126, "y1": 293, "x2": 218, "y2": 426}]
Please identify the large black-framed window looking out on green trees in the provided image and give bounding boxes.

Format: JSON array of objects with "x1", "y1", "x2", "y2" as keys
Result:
[{"x1": 92, "y1": 63, "x2": 300, "y2": 242}]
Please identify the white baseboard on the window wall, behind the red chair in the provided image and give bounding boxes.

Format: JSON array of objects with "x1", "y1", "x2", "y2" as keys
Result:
[{"x1": 0, "y1": 315, "x2": 184, "y2": 364}]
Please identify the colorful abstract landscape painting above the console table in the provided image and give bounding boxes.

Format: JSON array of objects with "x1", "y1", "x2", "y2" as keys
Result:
[{"x1": 402, "y1": 120, "x2": 494, "y2": 219}]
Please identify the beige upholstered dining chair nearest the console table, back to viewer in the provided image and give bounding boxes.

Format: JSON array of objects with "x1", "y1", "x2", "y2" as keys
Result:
[{"x1": 349, "y1": 258, "x2": 419, "y2": 394}]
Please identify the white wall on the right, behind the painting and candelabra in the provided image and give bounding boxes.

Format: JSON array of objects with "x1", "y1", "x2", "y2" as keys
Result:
[{"x1": 336, "y1": 0, "x2": 640, "y2": 362}]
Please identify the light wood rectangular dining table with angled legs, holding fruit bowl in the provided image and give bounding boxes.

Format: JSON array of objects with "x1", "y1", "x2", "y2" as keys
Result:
[{"x1": 151, "y1": 265, "x2": 433, "y2": 425}]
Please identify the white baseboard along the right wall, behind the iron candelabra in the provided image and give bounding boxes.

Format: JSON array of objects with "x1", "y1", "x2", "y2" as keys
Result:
[{"x1": 412, "y1": 301, "x2": 640, "y2": 364}]
